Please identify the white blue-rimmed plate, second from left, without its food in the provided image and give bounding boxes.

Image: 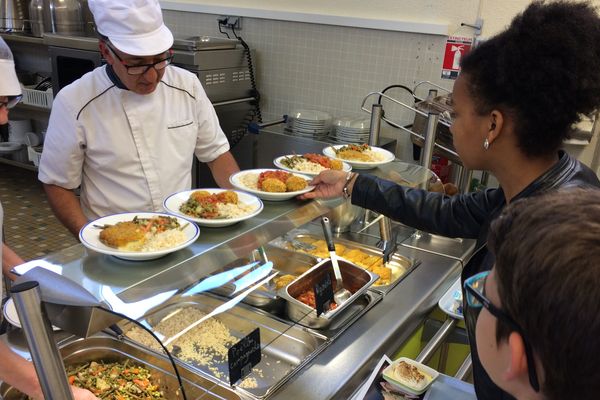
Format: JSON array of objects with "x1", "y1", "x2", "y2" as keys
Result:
[{"x1": 163, "y1": 189, "x2": 263, "y2": 228}]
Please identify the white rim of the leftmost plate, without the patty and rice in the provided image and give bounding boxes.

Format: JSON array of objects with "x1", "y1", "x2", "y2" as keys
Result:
[{"x1": 79, "y1": 212, "x2": 200, "y2": 261}]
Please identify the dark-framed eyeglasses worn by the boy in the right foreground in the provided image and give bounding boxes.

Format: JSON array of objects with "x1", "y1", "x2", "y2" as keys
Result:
[{"x1": 464, "y1": 271, "x2": 540, "y2": 392}]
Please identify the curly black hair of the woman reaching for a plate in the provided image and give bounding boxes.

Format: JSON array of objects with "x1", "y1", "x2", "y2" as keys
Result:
[{"x1": 461, "y1": 1, "x2": 600, "y2": 156}]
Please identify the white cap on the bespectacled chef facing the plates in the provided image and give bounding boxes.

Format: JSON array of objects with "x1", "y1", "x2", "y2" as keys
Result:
[{"x1": 88, "y1": 0, "x2": 173, "y2": 56}]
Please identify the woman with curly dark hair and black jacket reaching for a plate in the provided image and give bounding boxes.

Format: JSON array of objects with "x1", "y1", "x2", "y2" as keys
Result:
[{"x1": 303, "y1": 1, "x2": 600, "y2": 399}]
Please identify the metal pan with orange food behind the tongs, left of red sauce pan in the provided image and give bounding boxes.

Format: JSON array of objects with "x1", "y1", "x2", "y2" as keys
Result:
[{"x1": 212, "y1": 246, "x2": 317, "y2": 311}]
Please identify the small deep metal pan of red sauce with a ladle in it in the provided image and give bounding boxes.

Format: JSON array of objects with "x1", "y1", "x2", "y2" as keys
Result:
[{"x1": 280, "y1": 259, "x2": 378, "y2": 329}]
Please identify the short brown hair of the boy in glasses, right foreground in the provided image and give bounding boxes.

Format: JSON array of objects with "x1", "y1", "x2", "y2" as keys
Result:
[{"x1": 488, "y1": 189, "x2": 600, "y2": 400}]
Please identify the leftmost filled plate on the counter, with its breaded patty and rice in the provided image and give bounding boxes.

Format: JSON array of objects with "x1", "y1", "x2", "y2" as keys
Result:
[{"x1": 79, "y1": 212, "x2": 200, "y2": 261}]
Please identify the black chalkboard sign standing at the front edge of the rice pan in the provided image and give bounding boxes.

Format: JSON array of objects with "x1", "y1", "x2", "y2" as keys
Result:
[{"x1": 227, "y1": 328, "x2": 262, "y2": 386}]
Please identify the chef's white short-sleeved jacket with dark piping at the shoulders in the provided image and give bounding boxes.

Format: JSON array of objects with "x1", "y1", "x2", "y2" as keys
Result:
[{"x1": 39, "y1": 66, "x2": 229, "y2": 219}]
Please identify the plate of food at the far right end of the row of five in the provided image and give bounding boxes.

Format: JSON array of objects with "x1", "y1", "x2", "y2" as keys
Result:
[{"x1": 323, "y1": 143, "x2": 396, "y2": 169}]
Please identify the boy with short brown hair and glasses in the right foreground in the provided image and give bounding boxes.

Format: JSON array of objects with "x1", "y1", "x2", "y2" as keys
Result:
[{"x1": 464, "y1": 189, "x2": 600, "y2": 400}]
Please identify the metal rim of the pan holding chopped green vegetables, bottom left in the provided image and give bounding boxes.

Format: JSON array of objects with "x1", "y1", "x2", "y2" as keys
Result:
[{"x1": 0, "y1": 334, "x2": 241, "y2": 400}]
